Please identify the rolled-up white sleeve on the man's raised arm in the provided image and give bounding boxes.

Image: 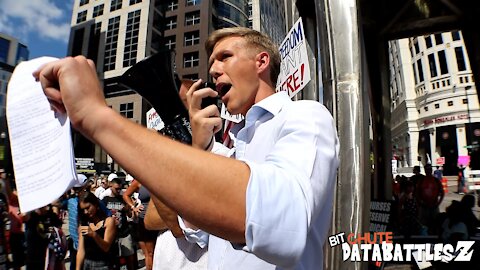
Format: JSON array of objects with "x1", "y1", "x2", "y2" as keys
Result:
[{"x1": 239, "y1": 102, "x2": 338, "y2": 268}]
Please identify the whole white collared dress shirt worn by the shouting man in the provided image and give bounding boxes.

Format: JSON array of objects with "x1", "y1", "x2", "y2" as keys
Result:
[{"x1": 183, "y1": 92, "x2": 339, "y2": 270}]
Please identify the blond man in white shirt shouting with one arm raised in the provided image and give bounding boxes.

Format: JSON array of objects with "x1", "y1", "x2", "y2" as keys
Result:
[{"x1": 33, "y1": 27, "x2": 339, "y2": 270}]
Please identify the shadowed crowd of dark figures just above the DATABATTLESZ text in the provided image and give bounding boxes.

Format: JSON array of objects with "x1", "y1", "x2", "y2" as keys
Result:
[{"x1": 393, "y1": 164, "x2": 480, "y2": 239}]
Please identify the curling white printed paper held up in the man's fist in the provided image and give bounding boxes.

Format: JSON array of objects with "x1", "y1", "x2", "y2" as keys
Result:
[{"x1": 6, "y1": 57, "x2": 78, "y2": 212}]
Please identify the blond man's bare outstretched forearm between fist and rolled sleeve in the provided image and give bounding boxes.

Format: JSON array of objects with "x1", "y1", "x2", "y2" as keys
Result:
[{"x1": 83, "y1": 107, "x2": 250, "y2": 242}]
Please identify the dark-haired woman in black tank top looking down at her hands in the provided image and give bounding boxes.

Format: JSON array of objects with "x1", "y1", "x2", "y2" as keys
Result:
[{"x1": 76, "y1": 192, "x2": 118, "y2": 270}]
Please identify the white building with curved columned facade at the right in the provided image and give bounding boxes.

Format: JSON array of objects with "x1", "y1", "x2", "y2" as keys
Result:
[{"x1": 390, "y1": 31, "x2": 480, "y2": 175}]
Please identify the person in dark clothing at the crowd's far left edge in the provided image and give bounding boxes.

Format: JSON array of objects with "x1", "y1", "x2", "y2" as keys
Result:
[{"x1": 8, "y1": 190, "x2": 25, "y2": 270}]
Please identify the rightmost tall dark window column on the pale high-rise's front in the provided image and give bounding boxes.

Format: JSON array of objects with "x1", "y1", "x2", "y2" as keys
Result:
[{"x1": 123, "y1": 10, "x2": 140, "y2": 67}]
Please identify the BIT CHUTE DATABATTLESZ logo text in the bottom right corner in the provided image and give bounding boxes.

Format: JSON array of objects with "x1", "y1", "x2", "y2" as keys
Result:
[{"x1": 328, "y1": 232, "x2": 475, "y2": 262}]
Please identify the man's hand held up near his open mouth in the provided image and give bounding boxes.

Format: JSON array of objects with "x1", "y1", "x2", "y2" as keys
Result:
[{"x1": 187, "y1": 80, "x2": 222, "y2": 151}]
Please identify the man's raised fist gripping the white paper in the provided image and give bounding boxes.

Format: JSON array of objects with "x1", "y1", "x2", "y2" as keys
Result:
[{"x1": 33, "y1": 56, "x2": 108, "y2": 137}]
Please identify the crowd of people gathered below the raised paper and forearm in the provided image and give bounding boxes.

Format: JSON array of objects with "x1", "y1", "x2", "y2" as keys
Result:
[{"x1": 0, "y1": 174, "x2": 171, "y2": 270}]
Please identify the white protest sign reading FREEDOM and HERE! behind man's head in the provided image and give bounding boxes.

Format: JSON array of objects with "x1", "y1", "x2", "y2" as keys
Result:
[{"x1": 276, "y1": 18, "x2": 311, "y2": 97}]
